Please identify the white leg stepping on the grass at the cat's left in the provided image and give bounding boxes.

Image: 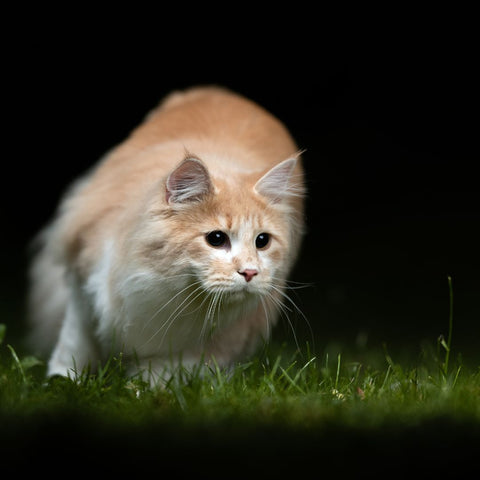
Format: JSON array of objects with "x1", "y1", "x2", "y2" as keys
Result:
[{"x1": 47, "y1": 287, "x2": 99, "y2": 378}]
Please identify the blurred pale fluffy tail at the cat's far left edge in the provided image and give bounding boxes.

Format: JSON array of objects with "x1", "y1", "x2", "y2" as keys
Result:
[{"x1": 27, "y1": 224, "x2": 68, "y2": 357}]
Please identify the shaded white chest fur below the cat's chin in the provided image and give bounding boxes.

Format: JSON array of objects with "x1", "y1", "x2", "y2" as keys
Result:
[{"x1": 85, "y1": 242, "x2": 259, "y2": 359}]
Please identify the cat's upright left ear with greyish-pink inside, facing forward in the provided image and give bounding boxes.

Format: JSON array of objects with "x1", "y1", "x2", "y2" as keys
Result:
[{"x1": 165, "y1": 158, "x2": 212, "y2": 203}]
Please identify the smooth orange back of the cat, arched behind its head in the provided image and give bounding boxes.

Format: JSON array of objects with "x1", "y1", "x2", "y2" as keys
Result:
[{"x1": 75, "y1": 87, "x2": 297, "y2": 195}]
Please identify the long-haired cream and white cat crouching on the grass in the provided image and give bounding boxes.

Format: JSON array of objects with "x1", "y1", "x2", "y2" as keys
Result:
[{"x1": 29, "y1": 86, "x2": 305, "y2": 384}]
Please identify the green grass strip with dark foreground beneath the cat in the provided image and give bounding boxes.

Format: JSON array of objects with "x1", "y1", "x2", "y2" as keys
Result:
[{"x1": 0, "y1": 280, "x2": 480, "y2": 478}]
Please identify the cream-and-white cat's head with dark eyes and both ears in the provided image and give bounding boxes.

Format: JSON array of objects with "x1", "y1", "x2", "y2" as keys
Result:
[{"x1": 141, "y1": 156, "x2": 303, "y2": 298}]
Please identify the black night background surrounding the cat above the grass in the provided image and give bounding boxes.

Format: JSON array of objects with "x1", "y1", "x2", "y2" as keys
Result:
[{"x1": 0, "y1": 23, "x2": 480, "y2": 361}]
